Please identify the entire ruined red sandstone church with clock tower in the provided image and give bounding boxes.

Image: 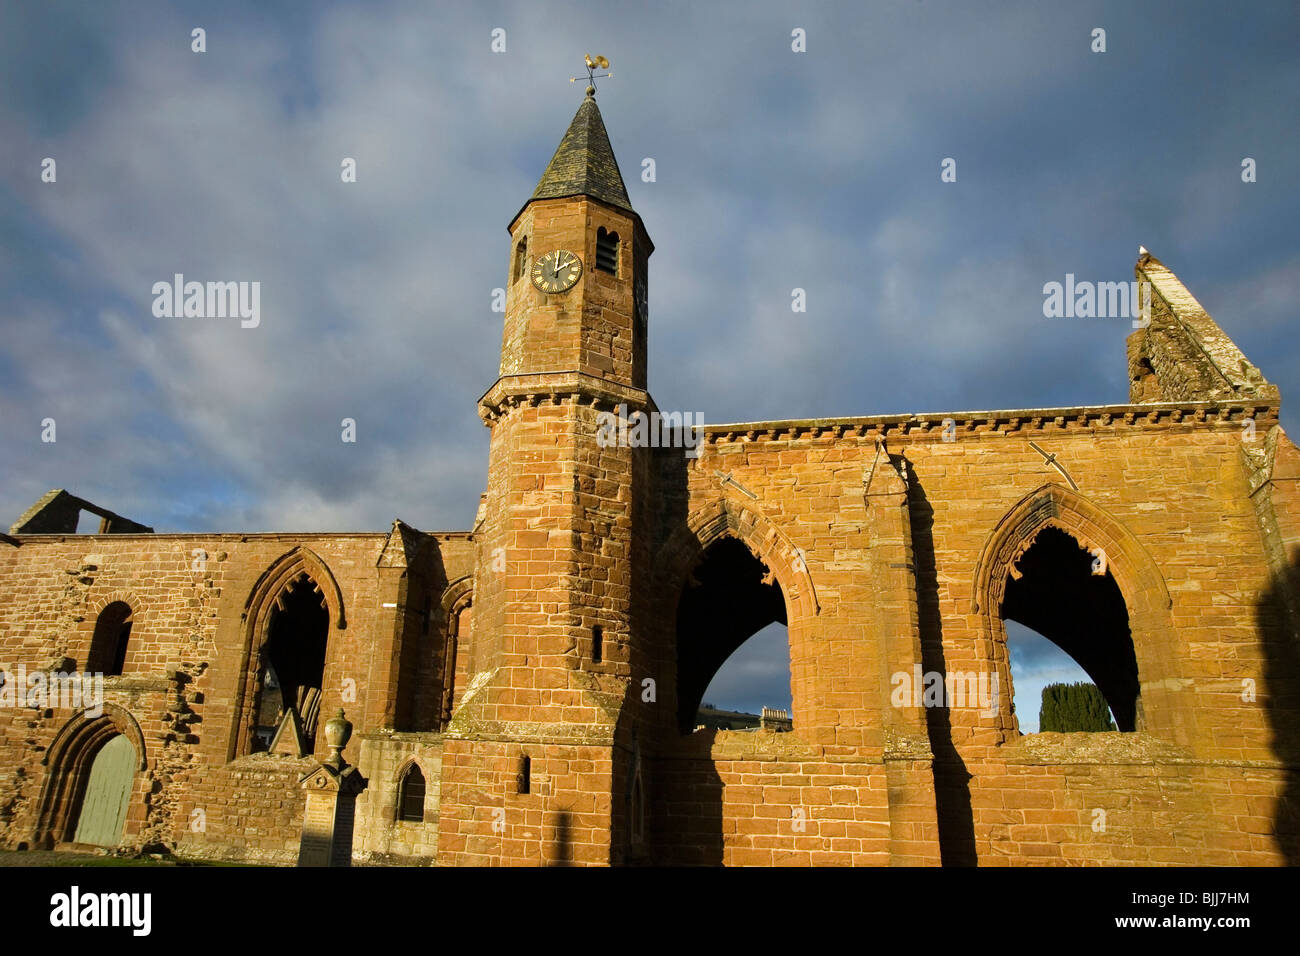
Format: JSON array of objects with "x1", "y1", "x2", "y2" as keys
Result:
[{"x1": 0, "y1": 91, "x2": 1300, "y2": 866}]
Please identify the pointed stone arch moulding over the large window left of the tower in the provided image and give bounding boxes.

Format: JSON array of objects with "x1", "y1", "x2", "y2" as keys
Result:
[{"x1": 228, "y1": 545, "x2": 347, "y2": 760}]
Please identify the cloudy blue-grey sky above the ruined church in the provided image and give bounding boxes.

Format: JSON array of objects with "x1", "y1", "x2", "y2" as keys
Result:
[{"x1": 0, "y1": 0, "x2": 1300, "y2": 723}]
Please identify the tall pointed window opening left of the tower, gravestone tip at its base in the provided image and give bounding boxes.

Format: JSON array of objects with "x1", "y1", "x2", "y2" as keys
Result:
[{"x1": 254, "y1": 572, "x2": 329, "y2": 752}]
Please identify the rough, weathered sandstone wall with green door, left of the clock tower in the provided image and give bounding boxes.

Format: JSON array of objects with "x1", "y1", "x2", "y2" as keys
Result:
[{"x1": 0, "y1": 533, "x2": 468, "y2": 864}]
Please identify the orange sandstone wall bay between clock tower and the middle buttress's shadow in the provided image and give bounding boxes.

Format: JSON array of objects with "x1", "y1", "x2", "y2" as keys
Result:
[{"x1": 649, "y1": 418, "x2": 940, "y2": 865}]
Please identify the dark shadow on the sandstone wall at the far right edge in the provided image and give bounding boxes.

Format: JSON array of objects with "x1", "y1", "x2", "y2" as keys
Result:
[{"x1": 1255, "y1": 548, "x2": 1300, "y2": 866}]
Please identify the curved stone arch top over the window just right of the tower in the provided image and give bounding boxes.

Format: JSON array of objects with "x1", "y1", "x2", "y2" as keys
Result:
[{"x1": 655, "y1": 498, "x2": 822, "y2": 627}]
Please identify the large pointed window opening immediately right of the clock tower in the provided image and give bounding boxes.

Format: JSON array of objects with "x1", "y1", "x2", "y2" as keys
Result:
[{"x1": 677, "y1": 537, "x2": 792, "y2": 734}]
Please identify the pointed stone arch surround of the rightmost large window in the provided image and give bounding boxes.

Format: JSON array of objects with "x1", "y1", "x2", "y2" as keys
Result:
[{"x1": 971, "y1": 483, "x2": 1191, "y2": 743}]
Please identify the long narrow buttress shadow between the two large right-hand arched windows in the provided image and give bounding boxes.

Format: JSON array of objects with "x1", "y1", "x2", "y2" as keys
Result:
[{"x1": 907, "y1": 468, "x2": 978, "y2": 866}]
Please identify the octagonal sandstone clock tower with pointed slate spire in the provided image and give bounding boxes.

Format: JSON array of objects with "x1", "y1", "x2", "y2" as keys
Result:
[{"x1": 439, "y1": 90, "x2": 653, "y2": 864}]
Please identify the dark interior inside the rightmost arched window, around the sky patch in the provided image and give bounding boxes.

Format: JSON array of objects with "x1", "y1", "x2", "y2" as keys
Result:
[{"x1": 1001, "y1": 527, "x2": 1139, "y2": 731}]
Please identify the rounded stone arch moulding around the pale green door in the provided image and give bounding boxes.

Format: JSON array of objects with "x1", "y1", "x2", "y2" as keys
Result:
[{"x1": 35, "y1": 704, "x2": 148, "y2": 845}]
